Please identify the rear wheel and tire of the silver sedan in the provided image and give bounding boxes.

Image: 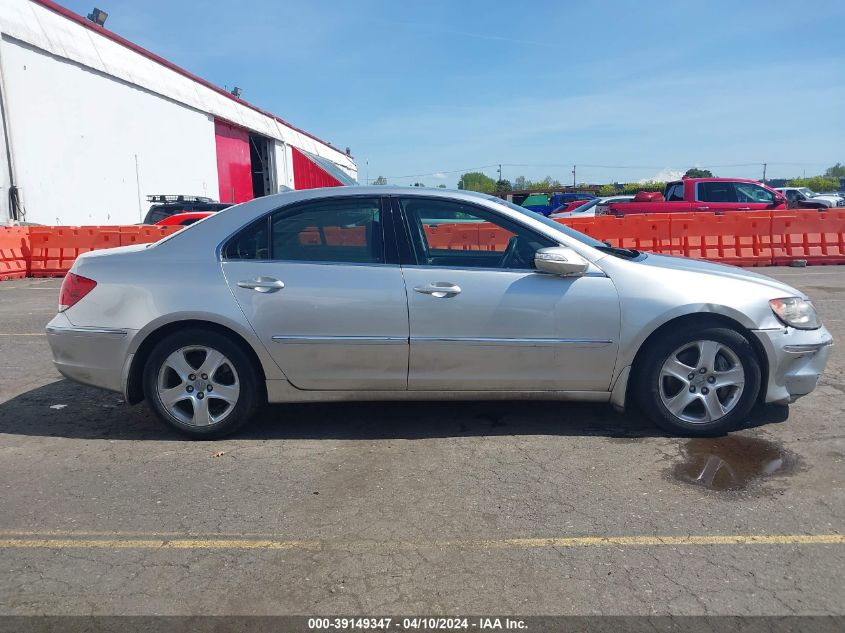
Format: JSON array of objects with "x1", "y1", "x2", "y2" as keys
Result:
[{"x1": 143, "y1": 328, "x2": 264, "y2": 439}]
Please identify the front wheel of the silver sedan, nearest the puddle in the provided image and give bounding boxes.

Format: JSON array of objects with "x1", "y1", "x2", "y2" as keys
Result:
[{"x1": 635, "y1": 327, "x2": 761, "y2": 437}]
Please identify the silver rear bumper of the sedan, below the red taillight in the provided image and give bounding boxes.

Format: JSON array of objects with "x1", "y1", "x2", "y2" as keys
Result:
[{"x1": 47, "y1": 312, "x2": 135, "y2": 391}]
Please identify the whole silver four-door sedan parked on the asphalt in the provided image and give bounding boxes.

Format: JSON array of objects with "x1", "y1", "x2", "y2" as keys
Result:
[{"x1": 47, "y1": 187, "x2": 832, "y2": 438}]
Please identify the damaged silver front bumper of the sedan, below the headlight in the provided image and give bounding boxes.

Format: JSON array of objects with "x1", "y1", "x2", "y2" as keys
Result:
[{"x1": 753, "y1": 327, "x2": 833, "y2": 404}]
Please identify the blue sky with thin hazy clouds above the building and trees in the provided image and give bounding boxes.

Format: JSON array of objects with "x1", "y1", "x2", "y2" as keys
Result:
[{"x1": 60, "y1": 0, "x2": 845, "y2": 187}]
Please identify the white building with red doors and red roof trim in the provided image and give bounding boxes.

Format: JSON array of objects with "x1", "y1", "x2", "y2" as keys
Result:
[{"x1": 0, "y1": 0, "x2": 357, "y2": 225}]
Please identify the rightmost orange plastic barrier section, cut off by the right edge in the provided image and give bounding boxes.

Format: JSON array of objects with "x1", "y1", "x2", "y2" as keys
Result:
[{"x1": 771, "y1": 209, "x2": 845, "y2": 264}]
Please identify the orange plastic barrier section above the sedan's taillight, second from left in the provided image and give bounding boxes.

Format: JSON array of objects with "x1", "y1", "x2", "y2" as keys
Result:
[{"x1": 29, "y1": 226, "x2": 120, "y2": 277}]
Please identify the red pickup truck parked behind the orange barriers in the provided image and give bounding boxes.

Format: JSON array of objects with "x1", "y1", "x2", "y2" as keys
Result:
[{"x1": 607, "y1": 178, "x2": 787, "y2": 216}]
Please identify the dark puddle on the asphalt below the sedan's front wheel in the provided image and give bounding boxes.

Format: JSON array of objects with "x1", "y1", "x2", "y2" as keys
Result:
[{"x1": 671, "y1": 435, "x2": 798, "y2": 490}]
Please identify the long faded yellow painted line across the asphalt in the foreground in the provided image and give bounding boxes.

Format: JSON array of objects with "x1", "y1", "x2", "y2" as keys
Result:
[{"x1": 0, "y1": 534, "x2": 845, "y2": 550}]
